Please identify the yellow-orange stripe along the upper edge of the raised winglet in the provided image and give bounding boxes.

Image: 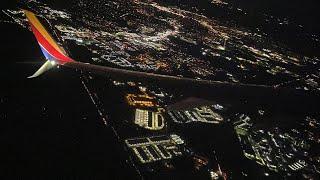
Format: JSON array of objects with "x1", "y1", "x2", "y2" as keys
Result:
[{"x1": 23, "y1": 10, "x2": 65, "y2": 54}]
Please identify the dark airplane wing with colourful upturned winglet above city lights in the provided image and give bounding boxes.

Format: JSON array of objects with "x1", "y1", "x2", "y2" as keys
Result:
[{"x1": 23, "y1": 10, "x2": 318, "y2": 100}]
